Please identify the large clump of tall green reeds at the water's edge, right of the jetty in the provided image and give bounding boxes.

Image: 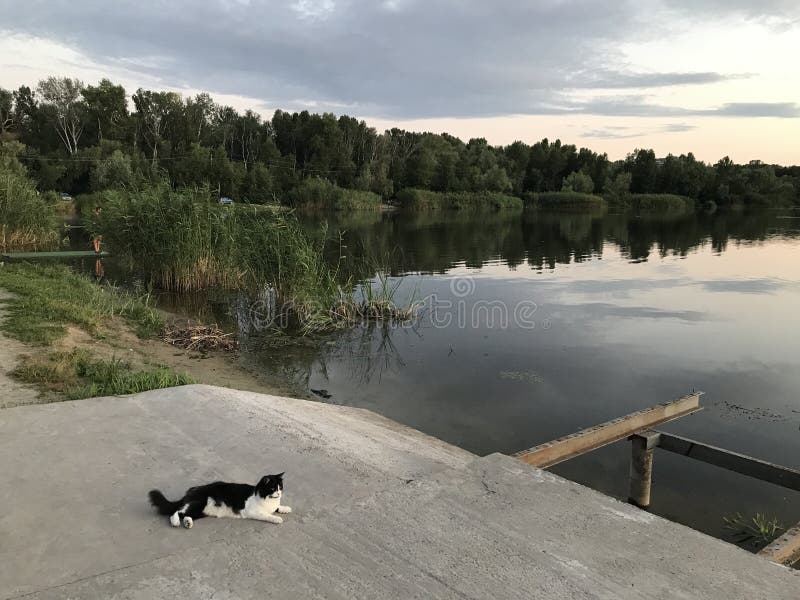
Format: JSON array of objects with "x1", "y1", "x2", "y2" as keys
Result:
[{"x1": 93, "y1": 186, "x2": 347, "y2": 312}]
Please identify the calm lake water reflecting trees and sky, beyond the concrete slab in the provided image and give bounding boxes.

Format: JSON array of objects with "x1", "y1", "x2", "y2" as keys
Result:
[{"x1": 87, "y1": 212, "x2": 800, "y2": 539}]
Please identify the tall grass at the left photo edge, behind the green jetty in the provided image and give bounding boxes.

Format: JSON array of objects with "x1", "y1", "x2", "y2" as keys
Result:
[{"x1": 0, "y1": 156, "x2": 59, "y2": 252}]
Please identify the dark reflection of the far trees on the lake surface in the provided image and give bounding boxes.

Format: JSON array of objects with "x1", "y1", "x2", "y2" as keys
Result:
[{"x1": 304, "y1": 211, "x2": 800, "y2": 278}]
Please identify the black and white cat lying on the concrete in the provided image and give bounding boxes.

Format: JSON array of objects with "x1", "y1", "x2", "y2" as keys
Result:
[{"x1": 149, "y1": 473, "x2": 292, "y2": 529}]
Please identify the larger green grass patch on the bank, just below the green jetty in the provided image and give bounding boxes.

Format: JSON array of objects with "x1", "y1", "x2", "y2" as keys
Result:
[{"x1": 0, "y1": 263, "x2": 164, "y2": 345}]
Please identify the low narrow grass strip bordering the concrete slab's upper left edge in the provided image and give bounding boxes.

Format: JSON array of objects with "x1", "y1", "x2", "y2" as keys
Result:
[{"x1": 14, "y1": 350, "x2": 194, "y2": 400}]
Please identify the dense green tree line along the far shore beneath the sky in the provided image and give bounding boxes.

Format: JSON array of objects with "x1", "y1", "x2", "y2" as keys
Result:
[{"x1": 0, "y1": 77, "x2": 800, "y2": 206}]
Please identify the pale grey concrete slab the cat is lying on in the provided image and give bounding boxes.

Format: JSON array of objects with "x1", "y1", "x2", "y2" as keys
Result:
[{"x1": 0, "y1": 386, "x2": 800, "y2": 600}]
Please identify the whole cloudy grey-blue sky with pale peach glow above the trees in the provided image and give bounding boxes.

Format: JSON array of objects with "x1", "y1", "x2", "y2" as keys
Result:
[{"x1": 0, "y1": 0, "x2": 800, "y2": 163}]
